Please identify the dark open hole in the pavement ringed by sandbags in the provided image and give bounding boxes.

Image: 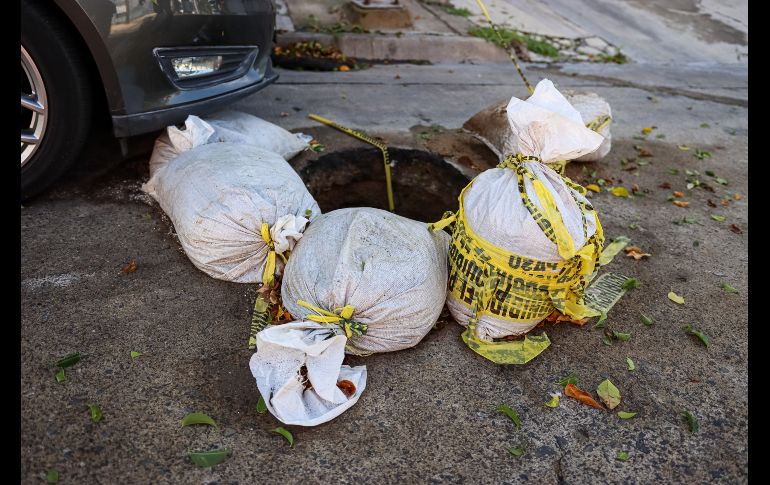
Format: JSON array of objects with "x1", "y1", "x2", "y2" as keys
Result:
[{"x1": 299, "y1": 148, "x2": 469, "y2": 222}]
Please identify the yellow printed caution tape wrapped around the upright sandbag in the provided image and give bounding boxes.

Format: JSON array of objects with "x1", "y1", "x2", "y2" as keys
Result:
[{"x1": 431, "y1": 154, "x2": 604, "y2": 364}]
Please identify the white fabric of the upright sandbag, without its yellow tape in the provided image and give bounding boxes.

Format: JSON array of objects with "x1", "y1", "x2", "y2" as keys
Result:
[{"x1": 447, "y1": 79, "x2": 603, "y2": 340}]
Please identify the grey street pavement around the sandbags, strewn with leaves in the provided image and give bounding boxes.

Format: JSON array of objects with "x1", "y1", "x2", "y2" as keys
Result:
[{"x1": 21, "y1": 61, "x2": 750, "y2": 484}]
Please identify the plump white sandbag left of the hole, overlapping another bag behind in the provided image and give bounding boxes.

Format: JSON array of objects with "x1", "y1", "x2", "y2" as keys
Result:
[{"x1": 142, "y1": 143, "x2": 321, "y2": 283}]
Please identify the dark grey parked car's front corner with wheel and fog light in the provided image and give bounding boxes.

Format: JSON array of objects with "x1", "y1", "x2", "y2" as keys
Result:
[{"x1": 21, "y1": 0, "x2": 278, "y2": 198}]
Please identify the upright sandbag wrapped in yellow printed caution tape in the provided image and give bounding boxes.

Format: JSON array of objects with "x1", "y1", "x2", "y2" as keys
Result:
[{"x1": 434, "y1": 79, "x2": 604, "y2": 363}]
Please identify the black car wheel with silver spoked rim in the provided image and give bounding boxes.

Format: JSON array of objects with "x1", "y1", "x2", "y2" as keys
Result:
[{"x1": 21, "y1": 1, "x2": 93, "y2": 199}]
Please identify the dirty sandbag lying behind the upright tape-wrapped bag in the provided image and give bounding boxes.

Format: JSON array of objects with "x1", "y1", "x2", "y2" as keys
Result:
[{"x1": 463, "y1": 91, "x2": 612, "y2": 162}]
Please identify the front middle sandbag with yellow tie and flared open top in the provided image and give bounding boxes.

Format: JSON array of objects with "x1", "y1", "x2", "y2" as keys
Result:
[{"x1": 250, "y1": 208, "x2": 449, "y2": 426}]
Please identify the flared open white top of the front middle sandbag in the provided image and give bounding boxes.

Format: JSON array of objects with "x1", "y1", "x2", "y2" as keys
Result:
[{"x1": 249, "y1": 321, "x2": 366, "y2": 426}]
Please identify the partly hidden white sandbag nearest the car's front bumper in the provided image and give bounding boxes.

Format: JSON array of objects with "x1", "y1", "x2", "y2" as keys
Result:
[{"x1": 150, "y1": 110, "x2": 312, "y2": 177}]
